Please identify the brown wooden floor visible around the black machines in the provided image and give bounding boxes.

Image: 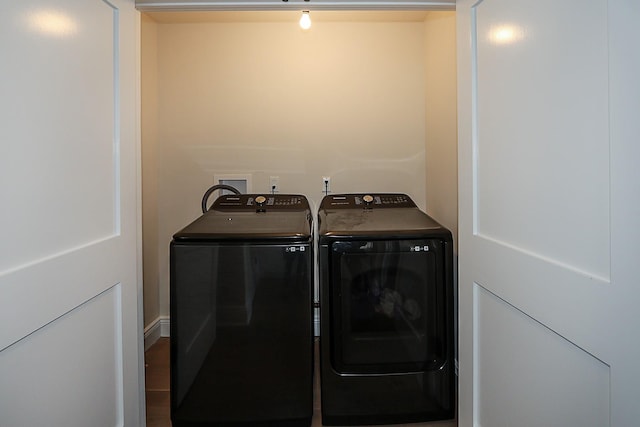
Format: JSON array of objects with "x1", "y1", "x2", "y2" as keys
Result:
[{"x1": 145, "y1": 338, "x2": 458, "y2": 427}]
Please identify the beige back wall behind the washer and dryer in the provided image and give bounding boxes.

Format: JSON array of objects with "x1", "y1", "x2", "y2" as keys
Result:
[{"x1": 142, "y1": 12, "x2": 455, "y2": 324}]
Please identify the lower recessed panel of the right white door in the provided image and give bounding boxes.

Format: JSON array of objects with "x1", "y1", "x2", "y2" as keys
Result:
[{"x1": 473, "y1": 285, "x2": 611, "y2": 427}]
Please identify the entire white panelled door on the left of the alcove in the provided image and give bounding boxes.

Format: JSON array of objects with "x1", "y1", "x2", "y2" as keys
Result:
[{"x1": 0, "y1": 0, "x2": 144, "y2": 426}]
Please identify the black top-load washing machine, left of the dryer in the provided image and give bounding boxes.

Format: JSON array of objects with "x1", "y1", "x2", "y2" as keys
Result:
[{"x1": 170, "y1": 194, "x2": 313, "y2": 427}]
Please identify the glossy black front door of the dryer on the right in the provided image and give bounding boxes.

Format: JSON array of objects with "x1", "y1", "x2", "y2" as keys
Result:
[{"x1": 330, "y1": 239, "x2": 447, "y2": 373}]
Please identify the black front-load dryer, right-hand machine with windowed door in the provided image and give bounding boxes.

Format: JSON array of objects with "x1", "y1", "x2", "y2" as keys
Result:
[{"x1": 318, "y1": 194, "x2": 455, "y2": 425}]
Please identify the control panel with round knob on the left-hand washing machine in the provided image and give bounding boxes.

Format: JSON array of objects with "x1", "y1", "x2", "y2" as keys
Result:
[{"x1": 211, "y1": 194, "x2": 309, "y2": 211}]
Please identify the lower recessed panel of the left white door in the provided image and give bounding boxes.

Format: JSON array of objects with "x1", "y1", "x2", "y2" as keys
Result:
[{"x1": 0, "y1": 285, "x2": 124, "y2": 427}]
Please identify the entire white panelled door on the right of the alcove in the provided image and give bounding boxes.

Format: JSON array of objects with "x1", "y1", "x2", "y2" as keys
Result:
[{"x1": 457, "y1": 0, "x2": 640, "y2": 427}]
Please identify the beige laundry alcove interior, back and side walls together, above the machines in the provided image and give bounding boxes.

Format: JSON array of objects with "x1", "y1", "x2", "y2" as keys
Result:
[{"x1": 137, "y1": 1, "x2": 457, "y2": 362}]
